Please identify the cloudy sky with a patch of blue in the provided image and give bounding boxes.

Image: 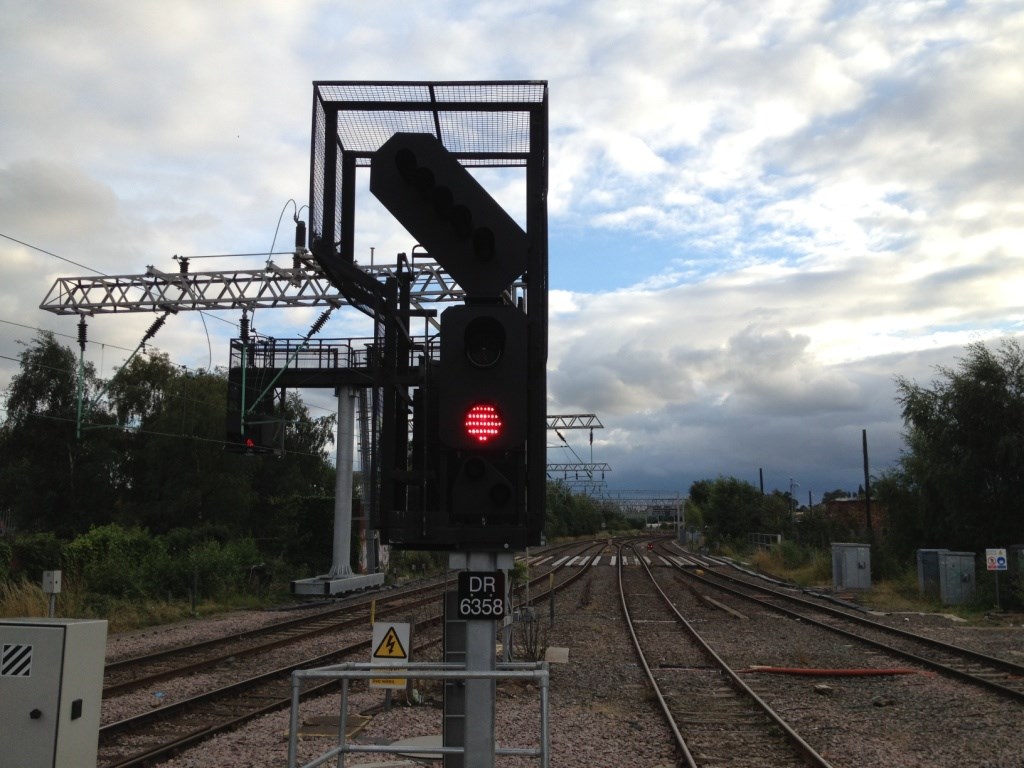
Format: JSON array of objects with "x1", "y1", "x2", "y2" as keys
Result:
[{"x1": 0, "y1": 0, "x2": 1024, "y2": 502}]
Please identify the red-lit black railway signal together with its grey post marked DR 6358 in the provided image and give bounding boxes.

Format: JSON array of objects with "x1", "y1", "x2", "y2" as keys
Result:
[{"x1": 370, "y1": 109, "x2": 547, "y2": 768}]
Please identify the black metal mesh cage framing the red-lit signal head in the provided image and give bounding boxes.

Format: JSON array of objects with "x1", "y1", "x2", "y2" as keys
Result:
[{"x1": 309, "y1": 81, "x2": 548, "y2": 549}]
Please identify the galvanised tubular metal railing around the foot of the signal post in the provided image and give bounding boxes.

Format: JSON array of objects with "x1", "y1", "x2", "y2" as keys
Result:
[{"x1": 288, "y1": 662, "x2": 551, "y2": 768}]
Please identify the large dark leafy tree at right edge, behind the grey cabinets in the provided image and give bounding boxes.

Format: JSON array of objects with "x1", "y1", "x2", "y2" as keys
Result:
[{"x1": 884, "y1": 339, "x2": 1024, "y2": 551}]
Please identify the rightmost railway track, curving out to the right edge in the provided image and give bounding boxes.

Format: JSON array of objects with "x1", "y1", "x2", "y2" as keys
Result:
[{"x1": 659, "y1": 548, "x2": 1024, "y2": 703}]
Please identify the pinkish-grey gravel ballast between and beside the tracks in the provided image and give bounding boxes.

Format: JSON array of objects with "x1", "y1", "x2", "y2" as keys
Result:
[{"x1": 104, "y1": 565, "x2": 1024, "y2": 768}]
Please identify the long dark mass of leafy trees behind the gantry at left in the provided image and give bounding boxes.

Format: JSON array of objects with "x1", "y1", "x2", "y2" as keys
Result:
[{"x1": 0, "y1": 333, "x2": 335, "y2": 549}]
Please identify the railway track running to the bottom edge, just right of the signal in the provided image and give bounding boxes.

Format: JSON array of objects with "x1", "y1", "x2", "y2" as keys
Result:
[{"x1": 617, "y1": 548, "x2": 829, "y2": 768}]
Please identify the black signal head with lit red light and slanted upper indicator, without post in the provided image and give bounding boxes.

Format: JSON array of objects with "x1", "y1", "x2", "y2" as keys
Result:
[{"x1": 370, "y1": 133, "x2": 546, "y2": 551}]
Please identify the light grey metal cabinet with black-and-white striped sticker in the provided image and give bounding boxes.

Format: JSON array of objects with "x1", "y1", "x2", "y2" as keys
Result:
[{"x1": 0, "y1": 618, "x2": 106, "y2": 768}]
